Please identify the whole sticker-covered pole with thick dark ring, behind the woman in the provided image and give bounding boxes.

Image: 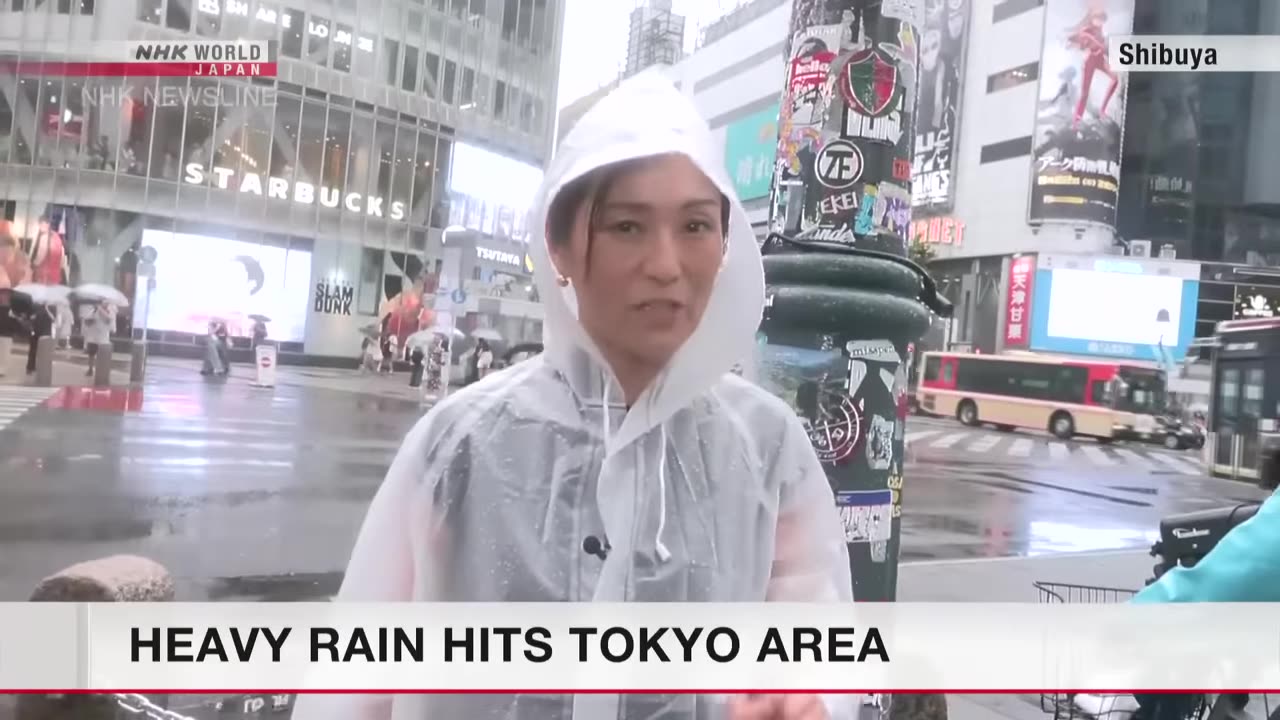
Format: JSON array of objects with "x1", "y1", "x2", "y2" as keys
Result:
[{"x1": 758, "y1": 0, "x2": 950, "y2": 609}]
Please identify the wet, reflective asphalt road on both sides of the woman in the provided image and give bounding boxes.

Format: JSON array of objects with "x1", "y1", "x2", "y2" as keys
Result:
[{"x1": 0, "y1": 373, "x2": 1261, "y2": 601}]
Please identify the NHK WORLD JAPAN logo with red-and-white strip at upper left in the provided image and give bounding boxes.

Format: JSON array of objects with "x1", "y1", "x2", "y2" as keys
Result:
[{"x1": 0, "y1": 40, "x2": 276, "y2": 77}]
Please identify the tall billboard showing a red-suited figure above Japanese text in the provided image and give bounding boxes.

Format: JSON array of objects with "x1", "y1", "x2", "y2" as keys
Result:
[{"x1": 1028, "y1": 0, "x2": 1133, "y2": 228}]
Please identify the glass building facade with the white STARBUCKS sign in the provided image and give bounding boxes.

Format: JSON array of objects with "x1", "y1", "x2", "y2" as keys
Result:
[{"x1": 0, "y1": 0, "x2": 563, "y2": 359}]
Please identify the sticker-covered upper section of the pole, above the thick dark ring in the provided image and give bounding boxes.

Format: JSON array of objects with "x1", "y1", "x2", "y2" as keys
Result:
[{"x1": 773, "y1": 0, "x2": 924, "y2": 255}]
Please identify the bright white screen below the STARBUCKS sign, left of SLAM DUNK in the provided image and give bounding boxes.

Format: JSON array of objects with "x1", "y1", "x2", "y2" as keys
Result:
[{"x1": 133, "y1": 229, "x2": 311, "y2": 342}]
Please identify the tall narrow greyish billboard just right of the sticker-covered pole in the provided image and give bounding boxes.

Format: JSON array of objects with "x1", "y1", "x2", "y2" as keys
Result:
[{"x1": 911, "y1": 0, "x2": 970, "y2": 213}]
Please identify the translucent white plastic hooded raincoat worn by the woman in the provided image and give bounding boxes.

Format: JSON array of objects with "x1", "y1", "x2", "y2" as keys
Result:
[{"x1": 294, "y1": 74, "x2": 854, "y2": 720}]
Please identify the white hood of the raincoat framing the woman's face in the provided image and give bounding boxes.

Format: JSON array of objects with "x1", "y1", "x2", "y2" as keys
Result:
[{"x1": 530, "y1": 72, "x2": 764, "y2": 452}]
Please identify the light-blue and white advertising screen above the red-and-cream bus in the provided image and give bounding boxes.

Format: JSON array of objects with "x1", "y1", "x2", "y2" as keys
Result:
[{"x1": 1030, "y1": 269, "x2": 1199, "y2": 363}]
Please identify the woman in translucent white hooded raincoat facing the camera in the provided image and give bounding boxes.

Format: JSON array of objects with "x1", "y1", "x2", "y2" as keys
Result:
[{"x1": 294, "y1": 74, "x2": 855, "y2": 720}]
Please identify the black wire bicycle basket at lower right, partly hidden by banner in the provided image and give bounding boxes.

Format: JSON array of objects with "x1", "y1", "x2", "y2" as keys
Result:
[{"x1": 1033, "y1": 582, "x2": 1207, "y2": 720}]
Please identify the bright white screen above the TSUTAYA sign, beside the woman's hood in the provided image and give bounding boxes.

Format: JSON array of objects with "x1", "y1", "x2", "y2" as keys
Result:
[{"x1": 449, "y1": 142, "x2": 543, "y2": 241}]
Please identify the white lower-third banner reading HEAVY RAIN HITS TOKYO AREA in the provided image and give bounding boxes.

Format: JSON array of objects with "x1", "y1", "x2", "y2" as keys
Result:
[{"x1": 0, "y1": 603, "x2": 1280, "y2": 693}]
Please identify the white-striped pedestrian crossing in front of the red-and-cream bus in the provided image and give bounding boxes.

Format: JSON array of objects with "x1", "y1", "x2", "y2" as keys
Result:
[{"x1": 906, "y1": 430, "x2": 1204, "y2": 475}]
